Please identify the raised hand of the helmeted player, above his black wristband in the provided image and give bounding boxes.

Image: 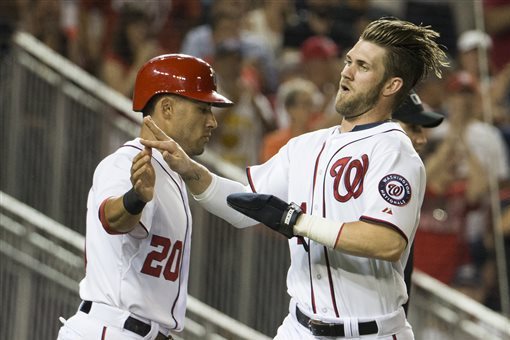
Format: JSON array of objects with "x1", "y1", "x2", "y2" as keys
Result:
[{"x1": 131, "y1": 148, "x2": 156, "y2": 202}]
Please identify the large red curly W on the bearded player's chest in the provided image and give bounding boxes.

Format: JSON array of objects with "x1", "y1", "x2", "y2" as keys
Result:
[{"x1": 329, "y1": 154, "x2": 368, "y2": 203}]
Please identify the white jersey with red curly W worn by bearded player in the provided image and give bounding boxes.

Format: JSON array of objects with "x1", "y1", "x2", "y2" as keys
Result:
[{"x1": 247, "y1": 122, "x2": 425, "y2": 320}]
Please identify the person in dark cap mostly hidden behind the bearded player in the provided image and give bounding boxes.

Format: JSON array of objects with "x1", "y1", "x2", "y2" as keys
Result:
[{"x1": 392, "y1": 90, "x2": 444, "y2": 314}]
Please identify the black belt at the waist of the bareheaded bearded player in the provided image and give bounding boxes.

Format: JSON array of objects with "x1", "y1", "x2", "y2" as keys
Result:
[{"x1": 296, "y1": 306, "x2": 379, "y2": 337}]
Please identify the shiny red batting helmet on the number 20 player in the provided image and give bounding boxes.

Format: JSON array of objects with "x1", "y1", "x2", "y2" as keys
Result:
[{"x1": 133, "y1": 54, "x2": 233, "y2": 111}]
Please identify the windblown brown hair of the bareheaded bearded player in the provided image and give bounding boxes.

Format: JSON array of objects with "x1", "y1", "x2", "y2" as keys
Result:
[{"x1": 360, "y1": 18, "x2": 449, "y2": 106}]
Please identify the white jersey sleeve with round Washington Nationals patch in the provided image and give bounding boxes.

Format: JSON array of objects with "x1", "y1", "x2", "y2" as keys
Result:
[{"x1": 360, "y1": 150, "x2": 425, "y2": 241}]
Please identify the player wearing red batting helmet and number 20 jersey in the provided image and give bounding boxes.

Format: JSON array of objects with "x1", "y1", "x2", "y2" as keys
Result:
[{"x1": 58, "y1": 54, "x2": 232, "y2": 340}]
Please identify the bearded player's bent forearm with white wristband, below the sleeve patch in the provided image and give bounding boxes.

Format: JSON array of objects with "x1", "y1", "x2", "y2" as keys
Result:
[{"x1": 294, "y1": 214, "x2": 406, "y2": 262}]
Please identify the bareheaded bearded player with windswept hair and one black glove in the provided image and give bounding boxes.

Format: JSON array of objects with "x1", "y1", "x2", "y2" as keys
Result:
[{"x1": 141, "y1": 19, "x2": 448, "y2": 340}]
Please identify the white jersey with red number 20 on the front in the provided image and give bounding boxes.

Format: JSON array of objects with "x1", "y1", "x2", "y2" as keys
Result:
[{"x1": 80, "y1": 139, "x2": 191, "y2": 331}]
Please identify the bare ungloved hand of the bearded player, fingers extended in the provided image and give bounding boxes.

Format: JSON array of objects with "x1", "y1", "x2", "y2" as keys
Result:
[{"x1": 140, "y1": 116, "x2": 192, "y2": 176}]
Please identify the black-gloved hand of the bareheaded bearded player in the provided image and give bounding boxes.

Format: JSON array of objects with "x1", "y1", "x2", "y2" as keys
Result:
[{"x1": 227, "y1": 193, "x2": 302, "y2": 238}]
